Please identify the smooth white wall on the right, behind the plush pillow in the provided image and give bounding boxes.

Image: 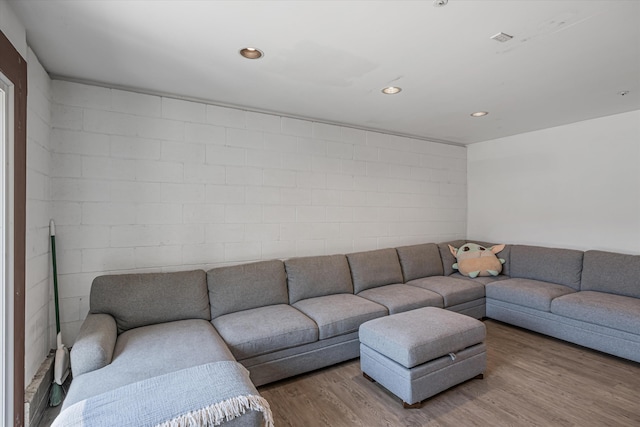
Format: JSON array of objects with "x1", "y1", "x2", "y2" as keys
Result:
[{"x1": 467, "y1": 111, "x2": 640, "y2": 254}]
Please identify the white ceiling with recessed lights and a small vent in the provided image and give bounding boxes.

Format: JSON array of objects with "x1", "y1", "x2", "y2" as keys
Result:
[{"x1": 9, "y1": 0, "x2": 640, "y2": 144}]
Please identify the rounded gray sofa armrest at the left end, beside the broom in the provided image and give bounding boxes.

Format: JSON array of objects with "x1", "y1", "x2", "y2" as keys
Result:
[{"x1": 71, "y1": 314, "x2": 118, "y2": 377}]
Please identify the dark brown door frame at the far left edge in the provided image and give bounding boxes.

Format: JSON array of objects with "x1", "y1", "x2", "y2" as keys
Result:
[{"x1": 0, "y1": 31, "x2": 27, "y2": 427}]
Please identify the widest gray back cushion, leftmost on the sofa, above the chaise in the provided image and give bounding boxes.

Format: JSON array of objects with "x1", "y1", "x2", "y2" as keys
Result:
[{"x1": 89, "y1": 270, "x2": 211, "y2": 334}]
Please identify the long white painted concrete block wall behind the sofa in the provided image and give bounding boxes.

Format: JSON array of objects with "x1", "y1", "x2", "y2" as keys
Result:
[{"x1": 51, "y1": 80, "x2": 467, "y2": 343}]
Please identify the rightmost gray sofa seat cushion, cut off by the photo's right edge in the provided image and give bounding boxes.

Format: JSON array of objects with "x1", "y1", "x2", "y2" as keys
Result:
[{"x1": 551, "y1": 291, "x2": 640, "y2": 334}]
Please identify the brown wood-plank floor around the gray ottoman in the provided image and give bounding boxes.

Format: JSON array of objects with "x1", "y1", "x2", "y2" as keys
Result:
[{"x1": 259, "y1": 320, "x2": 640, "y2": 427}]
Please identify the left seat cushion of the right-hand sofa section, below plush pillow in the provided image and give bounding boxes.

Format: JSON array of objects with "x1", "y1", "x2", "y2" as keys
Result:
[{"x1": 485, "y1": 278, "x2": 576, "y2": 311}]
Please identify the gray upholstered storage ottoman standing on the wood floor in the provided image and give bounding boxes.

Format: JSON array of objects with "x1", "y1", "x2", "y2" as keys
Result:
[{"x1": 359, "y1": 307, "x2": 487, "y2": 408}]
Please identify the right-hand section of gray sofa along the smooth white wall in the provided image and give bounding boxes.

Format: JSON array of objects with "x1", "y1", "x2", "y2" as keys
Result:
[{"x1": 486, "y1": 245, "x2": 640, "y2": 362}]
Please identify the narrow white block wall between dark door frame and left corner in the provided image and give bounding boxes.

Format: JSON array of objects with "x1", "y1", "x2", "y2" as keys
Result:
[{"x1": 25, "y1": 49, "x2": 55, "y2": 384}]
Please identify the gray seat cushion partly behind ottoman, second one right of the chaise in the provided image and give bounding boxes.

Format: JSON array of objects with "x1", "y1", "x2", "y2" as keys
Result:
[{"x1": 293, "y1": 294, "x2": 388, "y2": 340}]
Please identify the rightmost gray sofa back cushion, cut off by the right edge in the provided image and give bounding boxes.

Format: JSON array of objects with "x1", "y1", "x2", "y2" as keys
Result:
[{"x1": 580, "y1": 251, "x2": 640, "y2": 298}]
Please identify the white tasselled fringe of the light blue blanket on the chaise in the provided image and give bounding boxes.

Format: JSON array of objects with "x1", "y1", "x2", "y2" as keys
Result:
[{"x1": 156, "y1": 395, "x2": 274, "y2": 427}]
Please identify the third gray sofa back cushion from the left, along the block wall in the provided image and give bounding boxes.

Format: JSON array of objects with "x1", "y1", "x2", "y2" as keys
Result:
[{"x1": 284, "y1": 255, "x2": 353, "y2": 304}]
